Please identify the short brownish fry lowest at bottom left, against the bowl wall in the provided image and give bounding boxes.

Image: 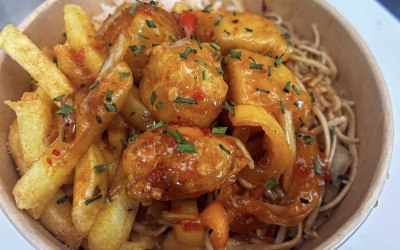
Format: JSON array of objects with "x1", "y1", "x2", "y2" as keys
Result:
[{"x1": 39, "y1": 190, "x2": 83, "y2": 249}]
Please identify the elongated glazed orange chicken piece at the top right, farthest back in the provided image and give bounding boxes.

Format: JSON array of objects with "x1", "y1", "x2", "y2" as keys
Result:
[{"x1": 195, "y1": 10, "x2": 293, "y2": 61}]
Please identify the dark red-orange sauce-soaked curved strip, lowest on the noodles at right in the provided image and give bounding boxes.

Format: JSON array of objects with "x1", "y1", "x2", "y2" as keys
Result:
[{"x1": 217, "y1": 140, "x2": 325, "y2": 226}]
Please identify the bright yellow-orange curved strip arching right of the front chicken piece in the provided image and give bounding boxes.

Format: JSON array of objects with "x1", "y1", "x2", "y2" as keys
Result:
[{"x1": 229, "y1": 105, "x2": 293, "y2": 185}]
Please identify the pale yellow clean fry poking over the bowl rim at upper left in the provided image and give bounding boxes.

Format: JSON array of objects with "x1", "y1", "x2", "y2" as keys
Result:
[{"x1": 0, "y1": 24, "x2": 74, "y2": 106}]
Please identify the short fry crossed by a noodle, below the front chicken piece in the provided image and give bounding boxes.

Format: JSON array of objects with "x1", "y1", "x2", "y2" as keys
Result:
[{"x1": 171, "y1": 199, "x2": 206, "y2": 247}]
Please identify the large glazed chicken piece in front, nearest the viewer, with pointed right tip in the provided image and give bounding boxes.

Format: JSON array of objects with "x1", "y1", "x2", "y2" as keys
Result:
[{"x1": 123, "y1": 126, "x2": 253, "y2": 203}]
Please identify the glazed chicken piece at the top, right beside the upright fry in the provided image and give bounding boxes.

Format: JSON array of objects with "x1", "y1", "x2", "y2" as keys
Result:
[{"x1": 102, "y1": 4, "x2": 183, "y2": 80}]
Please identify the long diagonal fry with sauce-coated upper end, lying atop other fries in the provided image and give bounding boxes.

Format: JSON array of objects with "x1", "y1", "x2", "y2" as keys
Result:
[{"x1": 13, "y1": 63, "x2": 133, "y2": 209}]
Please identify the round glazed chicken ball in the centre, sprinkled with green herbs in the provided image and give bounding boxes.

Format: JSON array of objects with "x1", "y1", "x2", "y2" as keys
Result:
[{"x1": 140, "y1": 38, "x2": 228, "y2": 128}]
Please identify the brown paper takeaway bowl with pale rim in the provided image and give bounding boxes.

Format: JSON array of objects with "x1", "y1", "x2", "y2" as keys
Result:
[{"x1": 0, "y1": 0, "x2": 393, "y2": 249}]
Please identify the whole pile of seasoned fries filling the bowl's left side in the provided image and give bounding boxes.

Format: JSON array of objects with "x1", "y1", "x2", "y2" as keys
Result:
[{"x1": 0, "y1": 5, "x2": 152, "y2": 249}]
